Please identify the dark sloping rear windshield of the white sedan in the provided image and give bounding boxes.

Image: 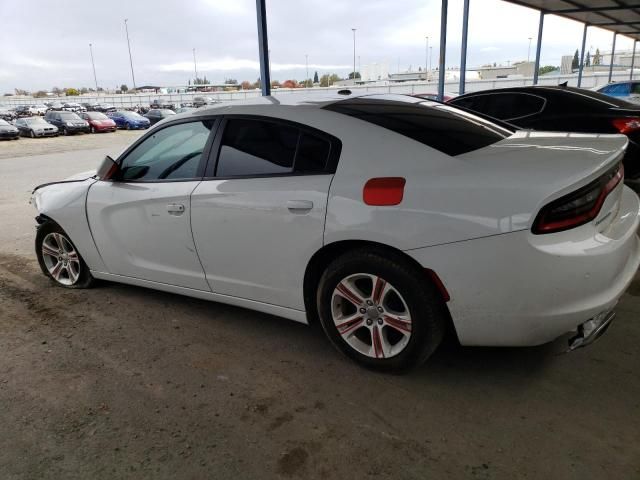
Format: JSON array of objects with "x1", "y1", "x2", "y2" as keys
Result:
[{"x1": 324, "y1": 97, "x2": 513, "y2": 156}]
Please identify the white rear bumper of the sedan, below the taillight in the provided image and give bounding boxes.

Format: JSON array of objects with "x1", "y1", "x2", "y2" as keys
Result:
[{"x1": 406, "y1": 188, "x2": 640, "y2": 346}]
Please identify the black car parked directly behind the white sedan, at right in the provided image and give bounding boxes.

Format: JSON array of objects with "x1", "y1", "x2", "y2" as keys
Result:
[{"x1": 449, "y1": 86, "x2": 640, "y2": 192}]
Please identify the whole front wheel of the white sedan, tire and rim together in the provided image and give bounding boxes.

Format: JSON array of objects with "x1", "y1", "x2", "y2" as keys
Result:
[{"x1": 36, "y1": 221, "x2": 94, "y2": 288}]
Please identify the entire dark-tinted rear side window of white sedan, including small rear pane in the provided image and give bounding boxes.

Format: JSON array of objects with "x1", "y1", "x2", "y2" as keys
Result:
[{"x1": 216, "y1": 118, "x2": 332, "y2": 177}]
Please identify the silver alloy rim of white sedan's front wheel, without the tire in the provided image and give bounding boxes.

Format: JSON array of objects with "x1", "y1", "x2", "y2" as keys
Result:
[{"x1": 42, "y1": 232, "x2": 81, "y2": 285}]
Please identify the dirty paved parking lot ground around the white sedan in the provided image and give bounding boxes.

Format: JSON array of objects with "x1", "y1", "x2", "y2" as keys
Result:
[{"x1": 0, "y1": 131, "x2": 640, "y2": 479}]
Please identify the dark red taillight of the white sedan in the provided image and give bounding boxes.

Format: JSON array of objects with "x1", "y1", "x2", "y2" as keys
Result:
[{"x1": 531, "y1": 164, "x2": 624, "y2": 235}]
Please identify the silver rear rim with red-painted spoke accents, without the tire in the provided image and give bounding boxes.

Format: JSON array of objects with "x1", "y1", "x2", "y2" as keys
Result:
[{"x1": 331, "y1": 273, "x2": 412, "y2": 358}]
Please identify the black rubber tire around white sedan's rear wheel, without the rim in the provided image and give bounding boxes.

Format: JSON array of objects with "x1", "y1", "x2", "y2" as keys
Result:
[{"x1": 317, "y1": 249, "x2": 448, "y2": 373}]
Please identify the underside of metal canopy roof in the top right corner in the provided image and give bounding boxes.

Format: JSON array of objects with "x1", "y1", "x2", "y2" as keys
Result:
[{"x1": 505, "y1": 0, "x2": 640, "y2": 40}]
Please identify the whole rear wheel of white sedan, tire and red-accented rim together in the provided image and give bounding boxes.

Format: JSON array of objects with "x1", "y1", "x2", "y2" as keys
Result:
[{"x1": 317, "y1": 250, "x2": 447, "y2": 372}]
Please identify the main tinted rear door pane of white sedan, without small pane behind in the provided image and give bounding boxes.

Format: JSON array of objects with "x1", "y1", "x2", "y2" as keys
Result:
[{"x1": 216, "y1": 119, "x2": 298, "y2": 177}]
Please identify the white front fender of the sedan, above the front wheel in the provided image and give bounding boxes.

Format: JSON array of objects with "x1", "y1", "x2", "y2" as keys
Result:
[{"x1": 31, "y1": 178, "x2": 106, "y2": 271}]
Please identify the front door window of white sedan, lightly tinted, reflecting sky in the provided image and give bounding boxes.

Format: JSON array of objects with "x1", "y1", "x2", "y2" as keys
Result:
[{"x1": 120, "y1": 120, "x2": 215, "y2": 182}]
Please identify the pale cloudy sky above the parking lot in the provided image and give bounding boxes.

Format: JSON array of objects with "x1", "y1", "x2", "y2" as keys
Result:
[{"x1": 0, "y1": 0, "x2": 632, "y2": 94}]
